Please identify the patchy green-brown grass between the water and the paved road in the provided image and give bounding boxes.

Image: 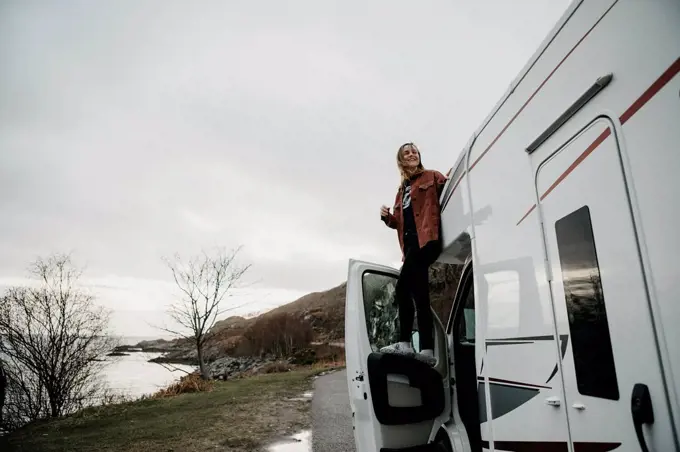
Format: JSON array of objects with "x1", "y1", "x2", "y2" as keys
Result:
[{"x1": 0, "y1": 365, "x2": 334, "y2": 452}]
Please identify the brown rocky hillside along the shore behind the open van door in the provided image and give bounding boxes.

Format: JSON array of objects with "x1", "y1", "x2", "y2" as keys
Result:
[{"x1": 133, "y1": 263, "x2": 461, "y2": 363}]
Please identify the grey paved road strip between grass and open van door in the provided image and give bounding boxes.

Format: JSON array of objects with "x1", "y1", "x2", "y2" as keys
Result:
[{"x1": 312, "y1": 369, "x2": 356, "y2": 452}]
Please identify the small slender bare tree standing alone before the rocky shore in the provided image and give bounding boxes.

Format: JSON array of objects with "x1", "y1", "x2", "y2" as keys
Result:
[{"x1": 163, "y1": 247, "x2": 250, "y2": 380}]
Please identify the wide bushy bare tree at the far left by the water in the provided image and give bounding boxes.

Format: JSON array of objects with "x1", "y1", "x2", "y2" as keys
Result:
[{"x1": 0, "y1": 254, "x2": 115, "y2": 429}]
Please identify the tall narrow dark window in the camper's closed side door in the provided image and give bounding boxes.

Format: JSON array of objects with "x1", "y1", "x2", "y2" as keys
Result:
[{"x1": 555, "y1": 206, "x2": 619, "y2": 400}]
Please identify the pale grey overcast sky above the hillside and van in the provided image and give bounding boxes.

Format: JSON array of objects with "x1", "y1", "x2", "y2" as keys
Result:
[{"x1": 0, "y1": 0, "x2": 568, "y2": 336}]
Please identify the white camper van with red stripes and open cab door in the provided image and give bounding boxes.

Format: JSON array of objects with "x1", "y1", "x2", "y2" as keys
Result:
[{"x1": 345, "y1": 0, "x2": 680, "y2": 452}]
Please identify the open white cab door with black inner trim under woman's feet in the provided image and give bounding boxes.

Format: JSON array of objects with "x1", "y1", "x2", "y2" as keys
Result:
[{"x1": 345, "y1": 260, "x2": 451, "y2": 452}]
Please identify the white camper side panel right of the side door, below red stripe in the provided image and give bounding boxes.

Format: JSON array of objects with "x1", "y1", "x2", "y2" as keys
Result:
[{"x1": 623, "y1": 75, "x2": 680, "y2": 431}]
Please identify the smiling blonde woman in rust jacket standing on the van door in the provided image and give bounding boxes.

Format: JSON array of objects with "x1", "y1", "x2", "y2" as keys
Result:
[{"x1": 380, "y1": 143, "x2": 447, "y2": 365}]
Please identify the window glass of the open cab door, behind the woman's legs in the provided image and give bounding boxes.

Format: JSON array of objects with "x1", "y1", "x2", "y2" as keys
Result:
[{"x1": 361, "y1": 272, "x2": 399, "y2": 352}]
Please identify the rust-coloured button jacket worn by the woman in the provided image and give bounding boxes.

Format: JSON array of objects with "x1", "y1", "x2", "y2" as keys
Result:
[{"x1": 382, "y1": 170, "x2": 447, "y2": 260}]
